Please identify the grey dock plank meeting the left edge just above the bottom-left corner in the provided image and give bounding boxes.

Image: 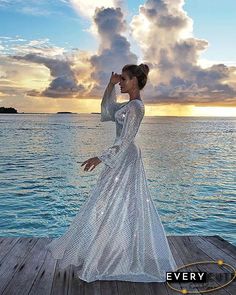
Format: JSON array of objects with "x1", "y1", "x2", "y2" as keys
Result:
[{"x1": 0, "y1": 238, "x2": 38, "y2": 294}]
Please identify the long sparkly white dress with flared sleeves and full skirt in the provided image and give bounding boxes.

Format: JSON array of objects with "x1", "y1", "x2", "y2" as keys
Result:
[{"x1": 46, "y1": 82, "x2": 177, "y2": 282}]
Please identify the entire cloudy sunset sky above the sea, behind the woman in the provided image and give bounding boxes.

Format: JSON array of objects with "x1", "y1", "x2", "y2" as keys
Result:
[{"x1": 0, "y1": 0, "x2": 236, "y2": 117}]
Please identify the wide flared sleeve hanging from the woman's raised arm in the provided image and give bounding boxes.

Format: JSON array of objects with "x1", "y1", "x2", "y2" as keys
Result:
[{"x1": 100, "y1": 83, "x2": 120, "y2": 122}]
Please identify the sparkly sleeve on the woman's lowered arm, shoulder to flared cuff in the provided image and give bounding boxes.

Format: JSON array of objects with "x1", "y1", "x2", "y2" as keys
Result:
[{"x1": 98, "y1": 102, "x2": 144, "y2": 168}]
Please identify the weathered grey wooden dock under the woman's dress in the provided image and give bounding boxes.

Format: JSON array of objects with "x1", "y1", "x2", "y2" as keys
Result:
[{"x1": 0, "y1": 236, "x2": 236, "y2": 295}]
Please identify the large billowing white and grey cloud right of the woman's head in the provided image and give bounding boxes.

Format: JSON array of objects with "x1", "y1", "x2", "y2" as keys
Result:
[{"x1": 131, "y1": 0, "x2": 236, "y2": 103}]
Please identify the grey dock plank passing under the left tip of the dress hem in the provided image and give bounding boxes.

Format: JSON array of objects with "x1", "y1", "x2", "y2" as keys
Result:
[{"x1": 28, "y1": 238, "x2": 56, "y2": 295}]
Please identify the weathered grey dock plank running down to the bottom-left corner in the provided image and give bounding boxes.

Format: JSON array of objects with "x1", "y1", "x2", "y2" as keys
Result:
[{"x1": 2, "y1": 238, "x2": 47, "y2": 295}]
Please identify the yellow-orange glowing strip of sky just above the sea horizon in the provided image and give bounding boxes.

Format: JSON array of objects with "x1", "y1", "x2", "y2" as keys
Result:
[{"x1": 3, "y1": 96, "x2": 236, "y2": 117}]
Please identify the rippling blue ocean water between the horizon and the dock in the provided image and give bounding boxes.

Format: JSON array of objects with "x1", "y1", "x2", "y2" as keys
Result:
[{"x1": 0, "y1": 114, "x2": 236, "y2": 245}]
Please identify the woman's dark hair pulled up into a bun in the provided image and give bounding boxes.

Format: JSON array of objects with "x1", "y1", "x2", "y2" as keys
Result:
[{"x1": 122, "y1": 64, "x2": 149, "y2": 90}]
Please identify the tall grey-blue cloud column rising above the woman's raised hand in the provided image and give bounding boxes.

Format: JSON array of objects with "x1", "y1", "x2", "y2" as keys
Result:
[{"x1": 66, "y1": 0, "x2": 137, "y2": 96}]
